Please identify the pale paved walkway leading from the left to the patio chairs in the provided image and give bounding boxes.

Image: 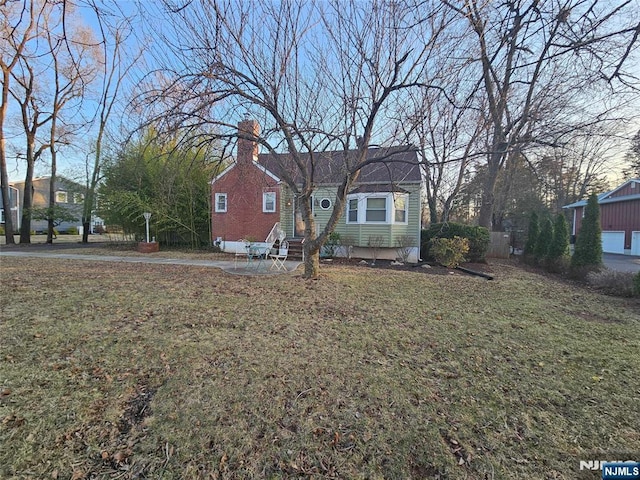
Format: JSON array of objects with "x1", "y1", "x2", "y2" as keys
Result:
[{"x1": 0, "y1": 248, "x2": 301, "y2": 275}]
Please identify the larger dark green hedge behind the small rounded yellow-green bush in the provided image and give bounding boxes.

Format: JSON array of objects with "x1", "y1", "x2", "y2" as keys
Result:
[{"x1": 420, "y1": 222, "x2": 490, "y2": 262}]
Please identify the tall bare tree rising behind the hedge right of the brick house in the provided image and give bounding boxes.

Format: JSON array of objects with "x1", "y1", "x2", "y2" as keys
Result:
[{"x1": 447, "y1": 0, "x2": 640, "y2": 231}]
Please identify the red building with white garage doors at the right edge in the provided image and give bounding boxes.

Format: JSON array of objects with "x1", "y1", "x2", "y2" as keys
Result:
[{"x1": 562, "y1": 178, "x2": 640, "y2": 255}]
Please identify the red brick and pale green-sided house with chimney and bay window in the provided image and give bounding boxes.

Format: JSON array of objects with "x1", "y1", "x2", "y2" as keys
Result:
[{"x1": 211, "y1": 120, "x2": 421, "y2": 262}]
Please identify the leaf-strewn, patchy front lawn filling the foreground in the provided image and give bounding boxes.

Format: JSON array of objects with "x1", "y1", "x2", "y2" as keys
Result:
[{"x1": 0, "y1": 258, "x2": 640, "y2": 479}]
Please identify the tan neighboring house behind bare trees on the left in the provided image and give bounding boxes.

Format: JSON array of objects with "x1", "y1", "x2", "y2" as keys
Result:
[{"x1": 12, "y1": 177, "x2": 91, "y2": 233}]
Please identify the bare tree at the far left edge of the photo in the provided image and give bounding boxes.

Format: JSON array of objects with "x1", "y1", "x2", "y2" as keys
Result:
[{"x1": 0, "y1": 1, "x2": 37, "y2": 244}]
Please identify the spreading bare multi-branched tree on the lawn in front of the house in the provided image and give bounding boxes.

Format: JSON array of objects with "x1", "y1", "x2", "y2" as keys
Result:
[{"x1": 140, "y1": 1, "x2": 445, "y2": 277}]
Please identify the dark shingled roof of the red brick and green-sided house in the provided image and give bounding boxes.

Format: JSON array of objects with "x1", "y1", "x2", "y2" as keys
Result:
[{"x1": 258, "y1": 146, "x2": 422, "y2": 185}]
